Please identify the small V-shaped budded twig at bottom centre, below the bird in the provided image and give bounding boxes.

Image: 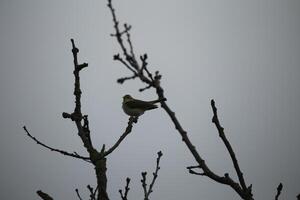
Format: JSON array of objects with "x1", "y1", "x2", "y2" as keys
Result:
[{"x1": 141, "y1": 151, "x2": 163, "y2": 200}]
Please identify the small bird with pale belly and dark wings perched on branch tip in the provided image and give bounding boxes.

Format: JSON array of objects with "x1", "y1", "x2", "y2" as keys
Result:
[{"x1": 122, "y1": 94, "x2": 167, "y2": 117}]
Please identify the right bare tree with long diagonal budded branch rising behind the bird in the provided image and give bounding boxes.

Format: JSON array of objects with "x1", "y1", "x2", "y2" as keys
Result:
[{"x1": 107, "y1": 0, "x2": 299, "y2": 200}]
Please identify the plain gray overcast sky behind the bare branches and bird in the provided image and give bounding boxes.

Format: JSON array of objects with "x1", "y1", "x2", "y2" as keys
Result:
[{"x1": 0, "y1": 0, "x2": 300, "y2": 200}]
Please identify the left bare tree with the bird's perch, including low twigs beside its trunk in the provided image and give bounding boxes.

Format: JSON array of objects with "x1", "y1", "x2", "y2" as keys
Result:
[{"x1": 23, "y1": 39, "x2": 163, "y2": 200}]
